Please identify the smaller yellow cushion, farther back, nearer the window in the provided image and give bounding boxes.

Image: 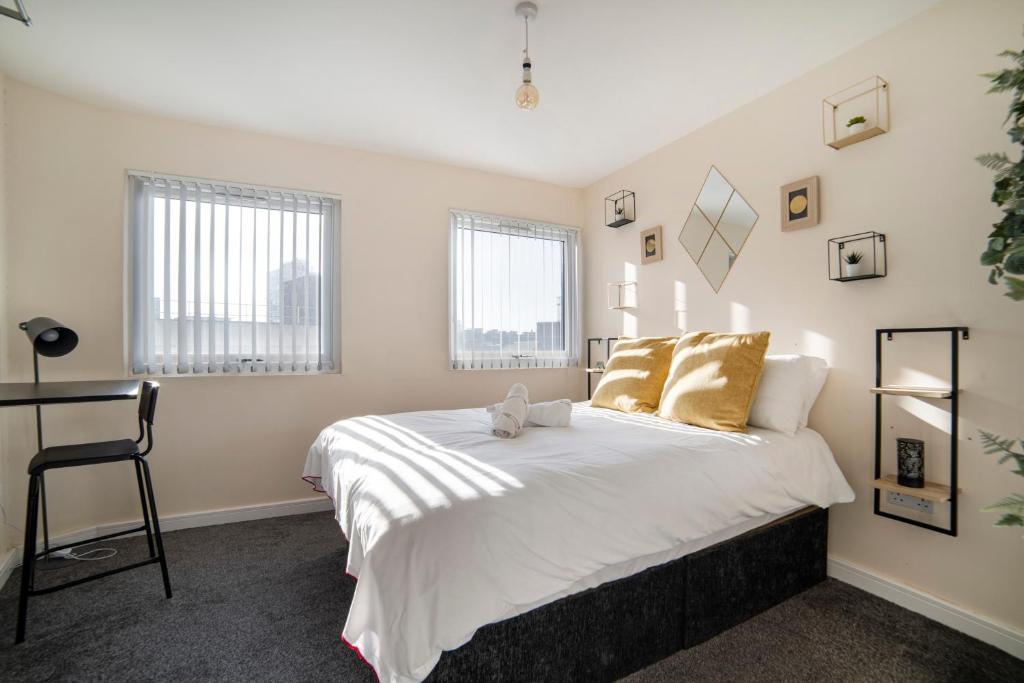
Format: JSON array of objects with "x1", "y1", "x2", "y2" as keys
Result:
[{"x1": 590, "y1": 337, "x2": 677, "y2": 413}]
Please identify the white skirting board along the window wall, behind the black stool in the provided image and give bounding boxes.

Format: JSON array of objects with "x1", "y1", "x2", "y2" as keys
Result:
[{"x1": 0, "y1": 496, "x2": 334, "y2": 589}]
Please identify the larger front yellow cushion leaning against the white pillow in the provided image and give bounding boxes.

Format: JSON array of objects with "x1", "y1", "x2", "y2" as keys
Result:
[{"x1": 657, "y1": 332, "x2": 771, "y2": 432}]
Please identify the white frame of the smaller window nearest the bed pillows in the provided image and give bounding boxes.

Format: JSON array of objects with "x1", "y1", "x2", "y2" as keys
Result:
[{"x1": 447, "y1": 209, "x2": 582, "y2": 371}]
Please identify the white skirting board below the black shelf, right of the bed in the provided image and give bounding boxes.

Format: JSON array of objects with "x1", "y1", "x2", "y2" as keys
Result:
[{"x1": 828, "y1": 558, "x2": 1024, "y2": 659}]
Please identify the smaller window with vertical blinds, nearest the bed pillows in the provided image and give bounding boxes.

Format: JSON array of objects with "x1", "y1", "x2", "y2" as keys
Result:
[{"x1": 450, "y1": 211, "x2": 580, "y2": 370}]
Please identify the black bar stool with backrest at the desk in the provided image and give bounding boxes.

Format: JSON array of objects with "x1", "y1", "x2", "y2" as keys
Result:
[{"x1": 14, "y1": 381, "x2": 171, "y2": 644}]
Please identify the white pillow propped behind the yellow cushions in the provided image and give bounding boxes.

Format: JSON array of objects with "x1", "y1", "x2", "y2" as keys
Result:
[{"x1": 746, "y1": 353, "x2": 828, "y2": 435}]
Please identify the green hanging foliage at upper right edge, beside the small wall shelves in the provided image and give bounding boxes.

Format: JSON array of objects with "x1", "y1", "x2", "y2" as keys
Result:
[{"x1": 978, "y1": 44, "x2": 1024, "y2": 301}]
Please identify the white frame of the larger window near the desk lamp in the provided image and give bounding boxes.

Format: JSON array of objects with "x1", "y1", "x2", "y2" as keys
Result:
[{"x1": 122, "y1": 169, "x2": 343, "y2": 379}]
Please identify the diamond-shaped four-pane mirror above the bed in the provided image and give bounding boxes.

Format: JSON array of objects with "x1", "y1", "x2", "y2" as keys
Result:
[{"x1": 679, "y1": 166, "x2": 758, "y2": 292}]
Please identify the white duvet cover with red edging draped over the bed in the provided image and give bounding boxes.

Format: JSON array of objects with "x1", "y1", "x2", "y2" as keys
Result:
[{"x1": 304, "y1": 403, "x2": 854, "y2": 683}]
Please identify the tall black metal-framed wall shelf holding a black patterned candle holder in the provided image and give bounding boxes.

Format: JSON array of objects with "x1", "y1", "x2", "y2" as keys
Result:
[{"x1": 870, "y1": 327, "x2": 971, "y2": 536}]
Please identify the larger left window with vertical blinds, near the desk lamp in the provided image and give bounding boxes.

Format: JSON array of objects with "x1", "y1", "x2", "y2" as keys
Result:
[{"x1": 128, "y1": 172, "x2": 341, "y2": 375}]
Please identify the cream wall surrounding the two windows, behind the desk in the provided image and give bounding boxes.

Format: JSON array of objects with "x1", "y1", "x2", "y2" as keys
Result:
[{"x1": 0, "y1": 80, "x2": 583, "y2": 544}]
